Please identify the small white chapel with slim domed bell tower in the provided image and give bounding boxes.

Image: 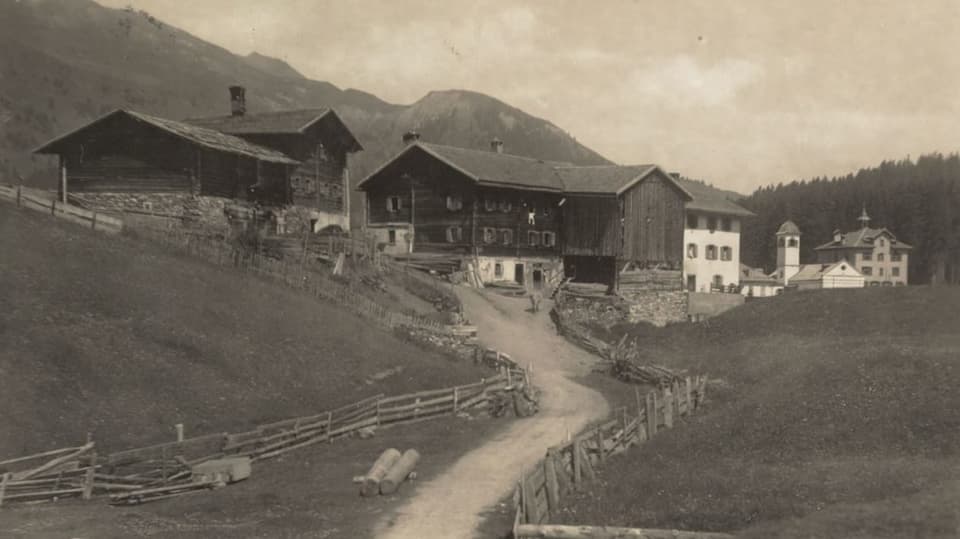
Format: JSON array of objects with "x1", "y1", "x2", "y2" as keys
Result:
[{"x1": 771, "y1": 221, "x2": 864, "y2": 290}]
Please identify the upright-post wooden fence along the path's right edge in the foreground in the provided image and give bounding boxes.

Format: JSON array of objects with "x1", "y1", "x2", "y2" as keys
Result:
[{"x1": 513, "y1": 377, "x2": 706, "y2": 539}]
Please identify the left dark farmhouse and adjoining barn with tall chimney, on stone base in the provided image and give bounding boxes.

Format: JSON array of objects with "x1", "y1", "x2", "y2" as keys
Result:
[{"x1": 36, "y1": 86, "x2": 362, "y2": 230}]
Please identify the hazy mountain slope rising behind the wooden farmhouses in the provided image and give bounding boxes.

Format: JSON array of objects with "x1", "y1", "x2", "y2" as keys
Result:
[{"x1": 0, "y1": 0, "x2": 606, "y2": 228}]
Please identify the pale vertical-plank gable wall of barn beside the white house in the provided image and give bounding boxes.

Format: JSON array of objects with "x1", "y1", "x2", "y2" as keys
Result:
[{"x1": 619, "y1": 174, "x2": 684, "y2": 265}]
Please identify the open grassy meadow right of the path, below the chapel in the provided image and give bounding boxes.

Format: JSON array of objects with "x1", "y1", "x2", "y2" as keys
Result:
[{"x1": 566, "y1": 287, "x2": 960, "y2": 538}]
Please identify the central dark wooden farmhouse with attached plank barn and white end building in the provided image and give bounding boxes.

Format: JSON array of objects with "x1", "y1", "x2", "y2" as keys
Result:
[{"x1": 360, "y1": 137, "x2": 750, "y2": 290}]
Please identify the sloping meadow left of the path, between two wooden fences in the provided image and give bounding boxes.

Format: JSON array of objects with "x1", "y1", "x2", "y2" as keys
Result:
[{"x1": 0, "y1": 204, "x2": 488, "y2": 455}]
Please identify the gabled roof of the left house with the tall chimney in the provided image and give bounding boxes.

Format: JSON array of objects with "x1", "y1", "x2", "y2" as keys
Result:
[{"x1": 184, "y1": 108, "x2": 363, "y2": 151}]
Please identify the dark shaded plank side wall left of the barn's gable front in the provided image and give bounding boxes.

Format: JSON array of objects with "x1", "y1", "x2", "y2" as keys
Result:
[{"x1": 562, "y1": 196, "x2": 620, "y2": 256}]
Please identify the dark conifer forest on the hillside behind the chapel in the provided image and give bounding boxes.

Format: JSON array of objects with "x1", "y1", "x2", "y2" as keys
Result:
[{"x1": 740, "y1": 154, "x2": 960, "y2": 284}]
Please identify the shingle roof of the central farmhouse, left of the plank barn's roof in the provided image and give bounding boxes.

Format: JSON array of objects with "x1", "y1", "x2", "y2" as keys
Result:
[{"x1": 415, "y1": 142, "x2": 563, "y2": 191}]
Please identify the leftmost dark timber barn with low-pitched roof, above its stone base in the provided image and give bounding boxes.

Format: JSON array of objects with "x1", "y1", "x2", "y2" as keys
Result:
[{"x1": 36, "y1": 110, "x2": 299, "y2": 209}]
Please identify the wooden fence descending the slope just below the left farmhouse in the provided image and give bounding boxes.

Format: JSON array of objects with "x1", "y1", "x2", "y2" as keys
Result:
[{"x1": 130, "y1": 228, "x2": 468, "y2": 335}]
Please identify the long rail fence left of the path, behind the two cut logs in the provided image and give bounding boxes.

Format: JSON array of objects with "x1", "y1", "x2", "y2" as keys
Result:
[{"x1": 0, "y1": 352, "x2": 530, "y2": 507}]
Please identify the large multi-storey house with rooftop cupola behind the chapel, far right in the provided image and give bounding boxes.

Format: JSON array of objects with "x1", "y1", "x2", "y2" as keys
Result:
[{"x1": 815, "y1": 207, "x2": 913, "y2": 286}]
